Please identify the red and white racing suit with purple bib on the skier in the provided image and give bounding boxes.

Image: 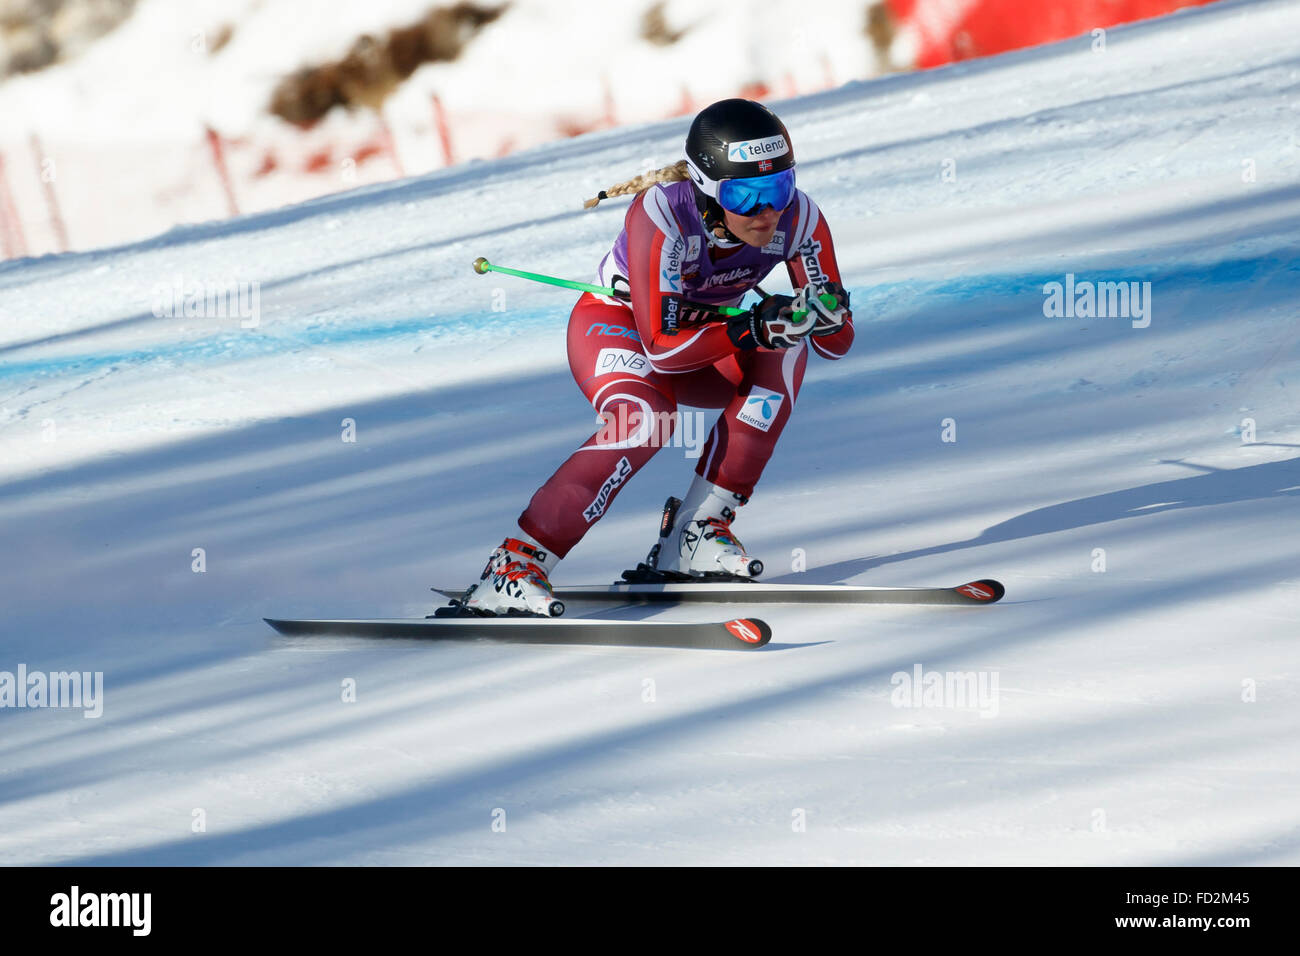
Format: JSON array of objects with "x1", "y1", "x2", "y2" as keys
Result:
[{"x1": 519, "y1": 182, "x2": 854, "y2": 557}]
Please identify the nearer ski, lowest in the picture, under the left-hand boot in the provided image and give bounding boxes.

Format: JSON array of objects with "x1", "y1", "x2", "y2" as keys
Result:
[{"x1": 263, "y1": 617, "x2": 772, "y2": 650}]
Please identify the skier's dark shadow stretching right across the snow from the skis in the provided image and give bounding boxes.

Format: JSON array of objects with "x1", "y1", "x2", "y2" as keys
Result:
[{"x1": 792, "y1": 455, "x2": 1300, "y2": 584}]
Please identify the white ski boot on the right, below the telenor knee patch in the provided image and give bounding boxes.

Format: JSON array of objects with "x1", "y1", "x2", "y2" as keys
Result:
[{"x1": 624, "y1": 477, "x2": 763, "y2": 581}]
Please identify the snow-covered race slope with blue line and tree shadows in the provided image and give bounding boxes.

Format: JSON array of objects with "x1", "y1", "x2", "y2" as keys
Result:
[{"x1": 0, "y1": 1, "x2": 1300, "y2": 864}]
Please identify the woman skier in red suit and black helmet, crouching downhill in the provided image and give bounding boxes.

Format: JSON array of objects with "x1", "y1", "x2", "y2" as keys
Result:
[{"x1": 463, "y1": 99, "x2": 853, "y2": 615}]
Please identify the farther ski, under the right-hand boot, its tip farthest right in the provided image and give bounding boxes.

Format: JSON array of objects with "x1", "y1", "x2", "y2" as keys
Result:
[{"x1": 434, "y1": 579, "x2": 1006, "y2": 606}]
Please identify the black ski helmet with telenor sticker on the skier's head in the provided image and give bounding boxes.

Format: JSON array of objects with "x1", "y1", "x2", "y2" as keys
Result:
[{"x1": 686, "y1": 99, "x2": 794, "y2": 241}]
